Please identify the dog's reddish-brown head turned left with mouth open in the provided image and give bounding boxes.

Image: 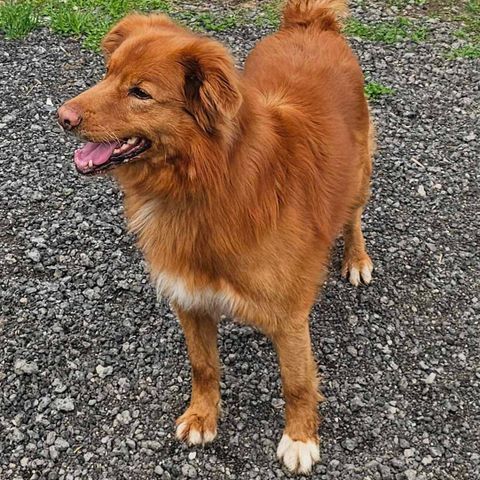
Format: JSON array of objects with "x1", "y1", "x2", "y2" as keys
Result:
[{"x1": 58, "y1": 14, "x2": 242, "y2": 178}]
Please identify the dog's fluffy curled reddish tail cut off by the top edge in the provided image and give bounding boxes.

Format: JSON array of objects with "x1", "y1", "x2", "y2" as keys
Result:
[{"x1": 282, "y1": 0, "x2": 348, "y2": 32}]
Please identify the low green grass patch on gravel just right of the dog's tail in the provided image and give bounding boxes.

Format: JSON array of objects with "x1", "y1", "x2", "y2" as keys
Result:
[{"x1": 344, "y1": 17, "x2": 428, "y2": 43}]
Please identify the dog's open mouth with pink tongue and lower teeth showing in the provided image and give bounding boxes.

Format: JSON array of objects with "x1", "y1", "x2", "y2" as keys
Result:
[{"x1": 74, "y1": 137, "x2": 151, "y2": 175}]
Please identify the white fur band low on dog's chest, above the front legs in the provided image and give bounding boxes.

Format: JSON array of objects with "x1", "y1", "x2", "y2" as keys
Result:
[{"x1": 154, "y1": 272, "x2": 236, "y2": 314}]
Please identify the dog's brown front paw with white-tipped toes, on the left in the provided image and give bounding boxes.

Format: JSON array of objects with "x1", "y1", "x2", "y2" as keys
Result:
[{"x1": 176, "y1": 408, "x2": 217, "y2": 445}]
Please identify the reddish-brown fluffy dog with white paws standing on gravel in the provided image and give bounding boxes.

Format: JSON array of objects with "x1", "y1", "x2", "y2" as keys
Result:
[{"x1": 58, "y1": 0, "x2": 375, "y2": 473}]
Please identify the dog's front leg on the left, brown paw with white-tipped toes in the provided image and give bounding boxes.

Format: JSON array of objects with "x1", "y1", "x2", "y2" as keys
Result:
[{"x1": 175, "y1": 307, "x2": 220, "y2": 445}]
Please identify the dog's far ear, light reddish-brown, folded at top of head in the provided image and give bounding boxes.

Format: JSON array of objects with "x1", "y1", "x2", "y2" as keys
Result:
[{"x1": 102, "y1": 13, "x2": 183, "y2": 60}]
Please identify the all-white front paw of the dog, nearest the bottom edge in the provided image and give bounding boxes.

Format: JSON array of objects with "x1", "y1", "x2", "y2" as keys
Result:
[{"x1": 277, "y1": 434, "x2": 320, "y2": 473}]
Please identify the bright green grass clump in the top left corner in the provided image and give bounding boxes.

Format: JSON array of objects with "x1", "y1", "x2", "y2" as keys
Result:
[{"x1": 0, "y1": 1, "x2": 39, "y2": 39}]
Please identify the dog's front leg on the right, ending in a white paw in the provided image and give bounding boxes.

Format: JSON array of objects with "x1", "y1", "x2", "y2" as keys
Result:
[{"x1": 272, "y1": 315, "x2": 322, "y2": 473}]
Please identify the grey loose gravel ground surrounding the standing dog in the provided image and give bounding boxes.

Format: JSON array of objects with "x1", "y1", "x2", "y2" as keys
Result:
[{"x1": 0, "y1": 1, "x2": 480, "y2": 480}]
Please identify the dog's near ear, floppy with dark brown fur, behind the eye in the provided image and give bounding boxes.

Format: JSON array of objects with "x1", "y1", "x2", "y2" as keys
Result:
[{"x1": 180, "y1": 39, "x2": 242, "y2": 134}]
